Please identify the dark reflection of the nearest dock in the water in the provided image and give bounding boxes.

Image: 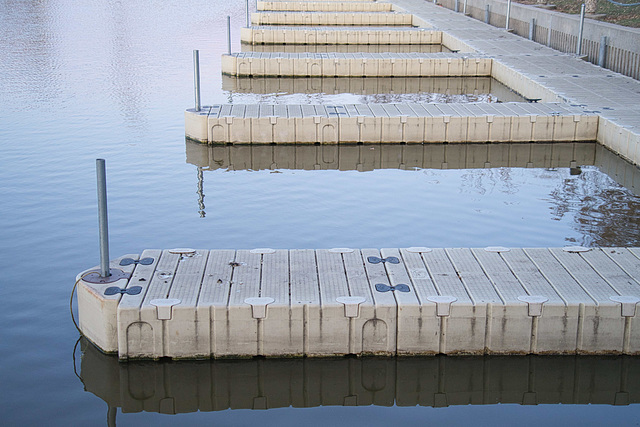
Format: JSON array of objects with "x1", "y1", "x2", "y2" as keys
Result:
[{"x1": 80, "y1": 340, "x2": 640, "y2": 420}]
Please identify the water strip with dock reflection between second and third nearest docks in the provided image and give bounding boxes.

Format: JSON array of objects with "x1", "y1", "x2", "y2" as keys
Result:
[{"x1": 222, "y1": 75, "x2": 524, "y2": 104}]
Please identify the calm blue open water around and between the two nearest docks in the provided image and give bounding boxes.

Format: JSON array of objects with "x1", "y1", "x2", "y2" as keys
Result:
[{"x1": 0, "y1": 0, "x2": 640, "y2": 426}]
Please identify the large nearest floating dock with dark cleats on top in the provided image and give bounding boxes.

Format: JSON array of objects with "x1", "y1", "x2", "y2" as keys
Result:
[{"x1": 78, "y1": 247, "x2": 640, "y2": 359}]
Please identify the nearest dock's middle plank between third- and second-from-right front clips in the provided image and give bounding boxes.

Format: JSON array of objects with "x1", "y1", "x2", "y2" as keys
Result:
[{"x1": 446, "y1": 248, "x2": 503, "y2": 304}]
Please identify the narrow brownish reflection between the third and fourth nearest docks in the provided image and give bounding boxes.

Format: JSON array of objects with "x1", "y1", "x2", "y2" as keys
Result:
[{"x1": 242, "y1": 43, "x2": 451, "y2": 53}]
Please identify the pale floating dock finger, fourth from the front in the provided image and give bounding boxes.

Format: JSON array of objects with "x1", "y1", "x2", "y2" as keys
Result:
[{"x1": 240, "y1": 26, "x2": 442, "y2": 45}]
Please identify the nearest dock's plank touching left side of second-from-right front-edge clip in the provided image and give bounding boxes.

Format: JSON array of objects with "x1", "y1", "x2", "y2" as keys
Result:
[{"x1": 471, "y1": 249, "x2": 527, "y2": 304}]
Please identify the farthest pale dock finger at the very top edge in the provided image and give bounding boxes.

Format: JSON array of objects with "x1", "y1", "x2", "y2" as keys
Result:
[{"x1": 256, "y1": 1, "x2": 393, "y2": 12}]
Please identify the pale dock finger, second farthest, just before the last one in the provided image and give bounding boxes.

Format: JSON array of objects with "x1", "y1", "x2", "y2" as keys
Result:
[{"x1": 251, "y1": 12, "x2": 413, "y2": 27}]
